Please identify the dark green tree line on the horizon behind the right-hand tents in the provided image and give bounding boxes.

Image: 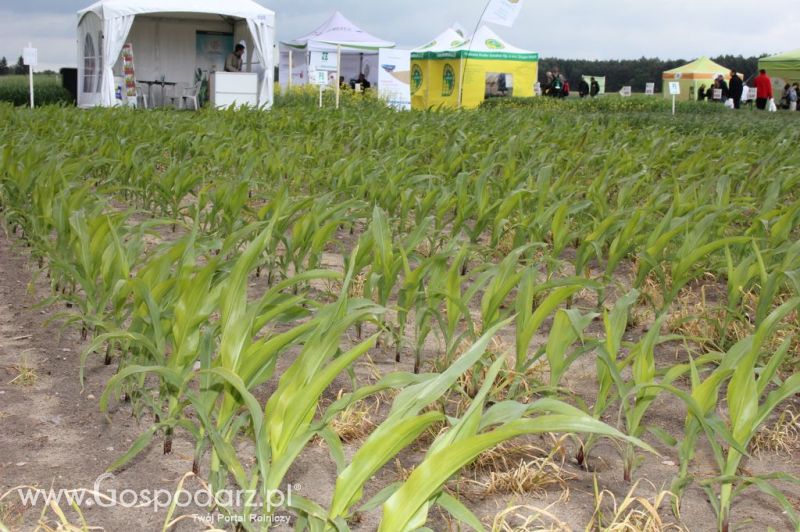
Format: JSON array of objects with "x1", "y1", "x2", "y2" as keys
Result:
[{"x1": 539, "y1": 54, "x2": 766, "y2": 92}]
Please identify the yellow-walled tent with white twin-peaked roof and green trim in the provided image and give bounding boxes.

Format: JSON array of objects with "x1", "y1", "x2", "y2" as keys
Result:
[{"x1": 411, "y1": 26, "x2": 539, "y2": 109}]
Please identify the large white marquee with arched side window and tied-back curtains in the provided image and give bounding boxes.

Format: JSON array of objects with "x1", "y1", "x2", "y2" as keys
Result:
[{"x1": 78, "y1": 0, "x2": 275, "y2": 107}]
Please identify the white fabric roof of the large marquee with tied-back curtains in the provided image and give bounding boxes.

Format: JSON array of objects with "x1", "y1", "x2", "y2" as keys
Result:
[{"x1": 78, "y1": 0, "x2": 275, "y2": 22}]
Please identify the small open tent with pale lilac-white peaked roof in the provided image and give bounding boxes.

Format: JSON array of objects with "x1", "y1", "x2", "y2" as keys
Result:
[{"x1": 279, "y1": 11, "x2": 395, "y2": 88}]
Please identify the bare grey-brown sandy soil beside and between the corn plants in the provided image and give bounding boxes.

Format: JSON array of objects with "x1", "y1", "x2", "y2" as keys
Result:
[{"x1": 0, "y1": 233, "x2": 800, "y2": 531}]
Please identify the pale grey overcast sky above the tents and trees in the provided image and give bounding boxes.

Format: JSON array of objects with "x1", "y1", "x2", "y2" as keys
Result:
[{"x1": 0, "y1": 0, "x2": 800, "y2": 69}]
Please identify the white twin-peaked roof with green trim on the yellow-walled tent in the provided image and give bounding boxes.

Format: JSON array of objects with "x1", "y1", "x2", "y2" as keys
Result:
[{"x1": 412, "y1": 25, "x2": 539, "y2": 61}]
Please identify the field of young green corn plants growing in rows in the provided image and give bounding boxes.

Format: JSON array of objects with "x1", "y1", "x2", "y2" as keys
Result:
[{"x1": 0, "y1": 97, "x2": 800, "y2": 532}]
